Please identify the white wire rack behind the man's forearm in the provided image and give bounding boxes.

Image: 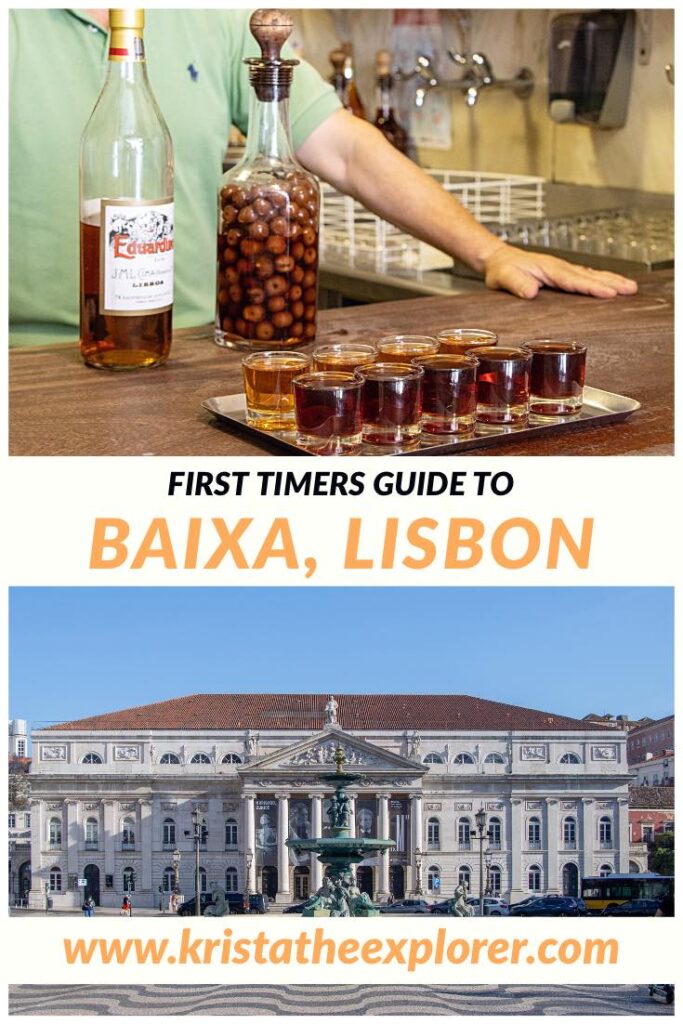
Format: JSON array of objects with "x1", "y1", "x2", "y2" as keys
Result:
[{"x1": 321, "y1": 169, "x2": 545, "y2": 270}]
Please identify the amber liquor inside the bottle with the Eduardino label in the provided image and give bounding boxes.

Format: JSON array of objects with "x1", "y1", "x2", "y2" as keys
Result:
[{"x1": 81, "y1": 221, "x2": 172, "y2": 370}]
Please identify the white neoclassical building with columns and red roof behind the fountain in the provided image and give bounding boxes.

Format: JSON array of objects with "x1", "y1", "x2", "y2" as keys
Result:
[{"x1": 30, "y1": 693, "x2": 631, "y2": 907}]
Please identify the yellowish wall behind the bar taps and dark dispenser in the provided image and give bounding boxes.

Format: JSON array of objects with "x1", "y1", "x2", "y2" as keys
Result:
[{"x1": 294, "y1": 9, "x2": 674, "y2": 191}]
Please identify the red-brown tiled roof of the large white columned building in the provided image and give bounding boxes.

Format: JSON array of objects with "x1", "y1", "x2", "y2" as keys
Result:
[{"x1": 44, "y1": 693, "x2": 603, "y2": 732}]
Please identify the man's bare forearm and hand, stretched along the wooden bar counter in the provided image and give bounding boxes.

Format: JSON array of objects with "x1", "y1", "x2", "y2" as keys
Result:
[{"x1": 297, "y1": 111, "x2": 637, "y2": 299}]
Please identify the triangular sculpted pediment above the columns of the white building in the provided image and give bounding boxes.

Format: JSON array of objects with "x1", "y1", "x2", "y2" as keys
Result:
[{"x1": 239, "y1": 726, "x2": 427, "y2": 780}]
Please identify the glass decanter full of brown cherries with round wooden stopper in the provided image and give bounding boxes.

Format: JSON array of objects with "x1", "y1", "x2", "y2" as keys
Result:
[{"x1": 216, "y1": 10, "x2": 319, "y2": 349}]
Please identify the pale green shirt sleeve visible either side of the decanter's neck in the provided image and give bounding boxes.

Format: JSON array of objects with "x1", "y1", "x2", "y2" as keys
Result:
[{"x1": 229, "y1": 10, "x2": 341, "y2": 150}]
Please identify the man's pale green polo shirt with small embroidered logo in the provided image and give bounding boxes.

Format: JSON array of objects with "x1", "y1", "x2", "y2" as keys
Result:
[{"x1": 9, "y1": 9, "x2": 339, "y2": 345}]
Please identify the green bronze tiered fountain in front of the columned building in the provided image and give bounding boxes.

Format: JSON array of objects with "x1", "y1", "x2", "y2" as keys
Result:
[{"x1": 286, "y1": 745, "x2": 395, "y2": 918}]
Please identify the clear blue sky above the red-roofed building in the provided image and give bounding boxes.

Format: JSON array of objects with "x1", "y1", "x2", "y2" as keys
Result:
[{"x1": 10, "y1": 587, "x2": 673, "y2": 727}]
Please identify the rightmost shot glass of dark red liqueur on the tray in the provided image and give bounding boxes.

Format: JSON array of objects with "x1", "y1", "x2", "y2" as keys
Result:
[{"x1": 524, "y1": 340, "x2": 586, "y2": 417}]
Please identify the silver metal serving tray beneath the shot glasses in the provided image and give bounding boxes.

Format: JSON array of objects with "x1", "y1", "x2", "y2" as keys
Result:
[{"x1": 202, "y1": 387, "x2": 640, "y2": 456}]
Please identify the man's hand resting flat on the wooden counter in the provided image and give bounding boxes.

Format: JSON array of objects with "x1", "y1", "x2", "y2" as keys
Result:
[{"x1": 483, "y1": 243, "x2": 638, "y2": 299}]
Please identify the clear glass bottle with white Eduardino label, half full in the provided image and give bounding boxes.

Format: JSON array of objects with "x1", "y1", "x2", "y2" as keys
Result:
[{"x1": 80, "y1": 10, "x2": 174, "y2": 370}]
